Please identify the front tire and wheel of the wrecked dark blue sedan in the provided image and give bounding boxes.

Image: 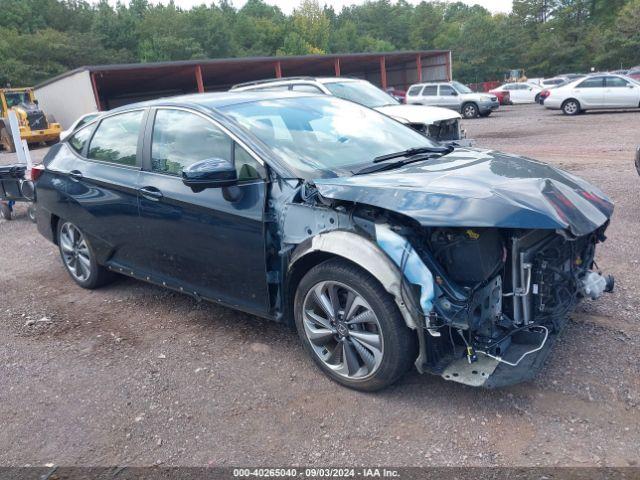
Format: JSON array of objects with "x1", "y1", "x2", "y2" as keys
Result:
[{"x1": 294, "y1": 259, "x2": 417, "y2": 392}]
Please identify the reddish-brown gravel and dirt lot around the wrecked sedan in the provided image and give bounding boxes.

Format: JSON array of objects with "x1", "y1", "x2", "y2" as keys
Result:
[{"x1": 0, "y1": 105, "x2": 640, "y2": 466}]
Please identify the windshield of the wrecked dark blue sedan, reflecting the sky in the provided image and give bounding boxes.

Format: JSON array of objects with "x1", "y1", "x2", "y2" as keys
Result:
[{"x1": 221, "y1": 96, "x2": 437, "y2": 179}]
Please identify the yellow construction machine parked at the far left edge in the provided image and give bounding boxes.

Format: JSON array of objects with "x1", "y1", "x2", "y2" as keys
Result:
[{"x1": 0, "y1": 88, "x2": 62, "y2": 152}]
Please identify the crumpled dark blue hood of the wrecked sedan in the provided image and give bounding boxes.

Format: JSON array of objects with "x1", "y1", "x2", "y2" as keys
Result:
[{"x1": 314, "y1": 149, "x2": 613, "y2": 236}]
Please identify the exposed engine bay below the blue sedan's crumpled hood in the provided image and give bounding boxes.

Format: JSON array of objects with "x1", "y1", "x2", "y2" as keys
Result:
[{"x1": 408, "y1": 226, "x2": 614, "y2": 386}]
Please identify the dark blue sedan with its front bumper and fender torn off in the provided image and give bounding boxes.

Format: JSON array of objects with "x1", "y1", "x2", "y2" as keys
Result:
[{"x1": 33, "y1": 91, "x2": 613, "y2": 390}]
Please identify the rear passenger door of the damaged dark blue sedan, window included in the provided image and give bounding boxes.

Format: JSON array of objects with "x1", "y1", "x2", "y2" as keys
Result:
[{"x1": 57, "y1": 109, "x2": 147, "y2": 269}]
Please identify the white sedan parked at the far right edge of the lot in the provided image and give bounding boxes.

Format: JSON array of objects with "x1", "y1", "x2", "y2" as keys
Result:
[{"x1": 544, "y1": 74, "x2": 640, "y2": 115}]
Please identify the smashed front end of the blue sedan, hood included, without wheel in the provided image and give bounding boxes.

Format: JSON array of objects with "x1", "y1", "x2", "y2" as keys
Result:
[{"x1": 277, "y1": 152, "x2": 614, "y2": 388}]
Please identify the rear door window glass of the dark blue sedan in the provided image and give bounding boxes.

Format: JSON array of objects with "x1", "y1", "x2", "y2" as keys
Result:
[{"x1": 87, "y1": 110, "x2": 144, "y2": 167}]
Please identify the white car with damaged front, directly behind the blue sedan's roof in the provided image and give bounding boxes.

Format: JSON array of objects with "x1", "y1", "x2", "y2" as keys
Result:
[{"x1": 231, "y1": 77, "x2": 469, "y2": 144}]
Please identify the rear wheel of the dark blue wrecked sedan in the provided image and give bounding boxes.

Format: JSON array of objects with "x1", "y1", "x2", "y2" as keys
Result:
[{"x1": 56, "y1": 220, "x2": 115, "y2": 290}]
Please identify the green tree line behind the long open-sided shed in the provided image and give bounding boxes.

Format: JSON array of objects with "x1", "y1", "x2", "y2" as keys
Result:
[{"x1": 0, "y1": 0, "x2": 640, "y2": 86}]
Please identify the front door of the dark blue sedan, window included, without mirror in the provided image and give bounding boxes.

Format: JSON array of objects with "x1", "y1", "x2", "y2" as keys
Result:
[{"x1": 138, "y1": 108, "x2": 269, "y2": 314}]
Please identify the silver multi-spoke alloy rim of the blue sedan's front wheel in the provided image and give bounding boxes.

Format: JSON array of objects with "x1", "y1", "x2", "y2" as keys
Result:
[{"x1": 302, "y1": 281, "x2": 383, "y2": 380}]
